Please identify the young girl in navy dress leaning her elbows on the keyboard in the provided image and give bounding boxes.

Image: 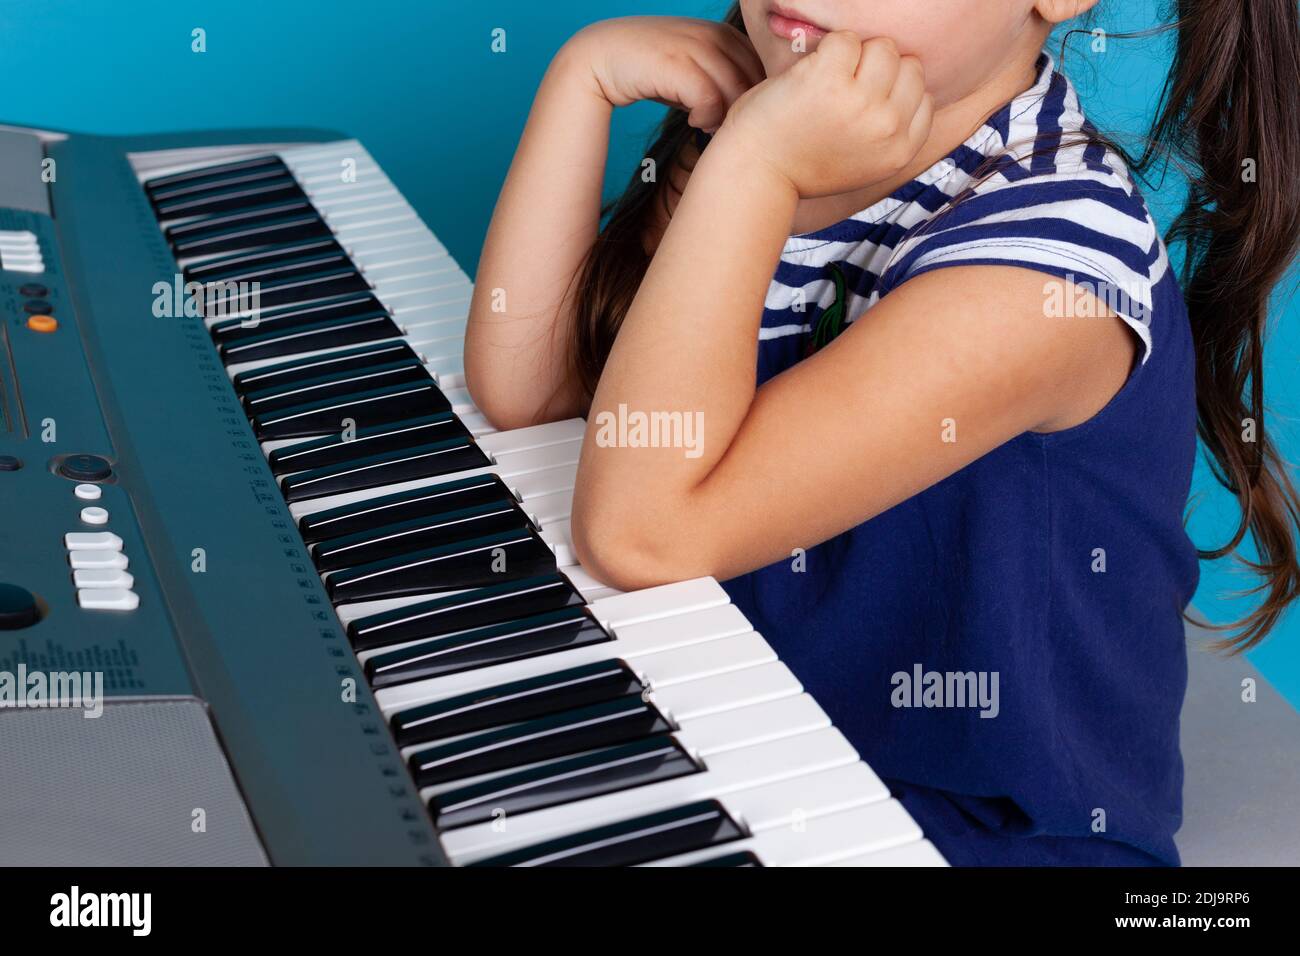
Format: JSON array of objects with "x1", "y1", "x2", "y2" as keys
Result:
[{"x1": 465, "y1": 0, "x2": 1300, "y2": 865}]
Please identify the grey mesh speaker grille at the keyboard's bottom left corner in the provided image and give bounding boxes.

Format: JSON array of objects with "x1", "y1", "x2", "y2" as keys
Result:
[{"x1": 0, "y1": 700, "x2": 267, "y2": 866}]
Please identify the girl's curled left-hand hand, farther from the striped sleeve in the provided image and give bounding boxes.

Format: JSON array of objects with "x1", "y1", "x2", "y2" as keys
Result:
[{"x1": 562, "y1": 17, "x2": 764, "y2": 133}]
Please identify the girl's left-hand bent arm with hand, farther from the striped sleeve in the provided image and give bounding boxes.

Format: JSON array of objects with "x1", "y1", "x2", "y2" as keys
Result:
[{"x1": 465, "y1": 17, "x2": 762, "y2": 428}]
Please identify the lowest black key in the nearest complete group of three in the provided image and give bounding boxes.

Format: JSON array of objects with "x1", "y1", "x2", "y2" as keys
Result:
[{"x1": 429, "y1": 735, "x2": 703, "y2": 830}]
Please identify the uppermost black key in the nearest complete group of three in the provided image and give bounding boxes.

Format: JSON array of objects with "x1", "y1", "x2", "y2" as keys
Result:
[{"x1": 389, "y1": 661, "x2": 642, "y2": 747}]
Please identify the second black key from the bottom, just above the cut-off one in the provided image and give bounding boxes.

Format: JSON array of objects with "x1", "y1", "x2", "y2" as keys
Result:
[{"x1": 471, "y1": 800, "x2": 746, "y2": 866}]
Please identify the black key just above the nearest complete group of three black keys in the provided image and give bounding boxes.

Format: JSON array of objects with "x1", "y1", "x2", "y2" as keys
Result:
[{"x1": 365, "y1": 607, "x2": 612, "y2": 688}]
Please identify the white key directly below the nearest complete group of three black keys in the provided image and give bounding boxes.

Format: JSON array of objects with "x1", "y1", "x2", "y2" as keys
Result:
[{"x1": 442, "y1": 723, "x2": 858, "y2": 864}]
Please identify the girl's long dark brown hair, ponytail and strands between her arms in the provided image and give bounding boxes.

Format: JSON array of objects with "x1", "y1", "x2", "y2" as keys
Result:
[{"x1": 571, "y1": 0, "x2": 1300, "y2": 652}]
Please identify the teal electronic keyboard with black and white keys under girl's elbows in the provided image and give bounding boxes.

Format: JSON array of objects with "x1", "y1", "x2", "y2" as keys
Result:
[{"x1": 0, "y1": 119, "x2": 943, "y2": 866}]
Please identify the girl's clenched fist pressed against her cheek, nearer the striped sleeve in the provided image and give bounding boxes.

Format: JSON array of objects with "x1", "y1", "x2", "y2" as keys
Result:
[{"x1": 720, "y1": 31, "x2": 933, "y2": 199}]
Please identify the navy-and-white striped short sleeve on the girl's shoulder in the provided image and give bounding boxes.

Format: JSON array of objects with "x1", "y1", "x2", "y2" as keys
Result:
[{"x1": 879, "y1": 170, "x2": 1169, "y2": 363}]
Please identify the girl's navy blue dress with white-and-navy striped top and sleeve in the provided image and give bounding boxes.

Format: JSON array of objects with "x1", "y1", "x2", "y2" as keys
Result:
[{"x1": 725, "y1": 56, "x2": 1197, "y2": 865}]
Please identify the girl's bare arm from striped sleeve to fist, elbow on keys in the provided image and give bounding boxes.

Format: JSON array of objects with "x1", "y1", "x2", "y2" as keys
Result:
[{"x1": 573, "y1": 34, "x2": 1132, "y2": 588}]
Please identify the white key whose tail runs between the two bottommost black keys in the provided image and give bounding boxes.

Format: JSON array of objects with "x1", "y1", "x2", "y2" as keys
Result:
[{"x1": 645, "y1": 800, "x2": 920, "y2": 866}]
